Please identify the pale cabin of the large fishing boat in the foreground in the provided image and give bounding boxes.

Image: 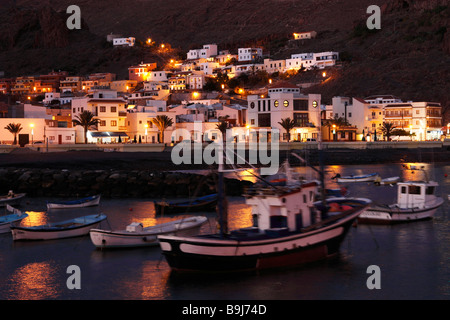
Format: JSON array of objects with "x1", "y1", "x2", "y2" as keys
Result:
[{"x1": 246, "y1": 182, "x2": 320, "y2": 231}]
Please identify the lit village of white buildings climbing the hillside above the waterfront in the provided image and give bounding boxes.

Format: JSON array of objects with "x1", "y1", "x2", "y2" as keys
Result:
[{"x1": 0, "y1": 31, "x2": 444, "y2": 146}]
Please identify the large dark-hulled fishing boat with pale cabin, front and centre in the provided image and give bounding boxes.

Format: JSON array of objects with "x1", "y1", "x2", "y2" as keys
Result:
[{"x1": 158, "y1": 175, "x2": 371, "y2": 272}]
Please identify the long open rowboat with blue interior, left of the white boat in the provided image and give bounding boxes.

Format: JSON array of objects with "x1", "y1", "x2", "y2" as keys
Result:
[{"x1": 11, "y1": 214, "x2": 106, "y2": 240}]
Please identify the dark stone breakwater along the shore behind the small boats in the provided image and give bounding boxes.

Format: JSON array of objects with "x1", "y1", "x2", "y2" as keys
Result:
[{"x1": 0, "y1": 168, "x2": 251, "y2": 198}]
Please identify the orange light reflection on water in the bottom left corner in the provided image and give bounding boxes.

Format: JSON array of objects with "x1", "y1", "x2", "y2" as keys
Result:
[{"x1": 11, "y1": 261, "x2": 60, "y2": 300}]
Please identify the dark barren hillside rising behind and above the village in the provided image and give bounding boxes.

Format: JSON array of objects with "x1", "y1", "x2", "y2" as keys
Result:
[{"x1": 0, "y1": 0, "x2": 450, "y2": 122}]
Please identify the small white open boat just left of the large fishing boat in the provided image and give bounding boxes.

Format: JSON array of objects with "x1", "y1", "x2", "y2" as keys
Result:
[{"x1": 89, "y1": 216, "x2": 208, "y2": 249}]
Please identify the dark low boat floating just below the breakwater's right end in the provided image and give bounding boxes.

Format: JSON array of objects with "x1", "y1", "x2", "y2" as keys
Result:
[{"x1": 154, "y1": 193, "x2": 217, "y2": 215}]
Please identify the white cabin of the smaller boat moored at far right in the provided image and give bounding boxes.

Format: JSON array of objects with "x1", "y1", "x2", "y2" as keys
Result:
[{"x1": 397, "y1": 181, "x2": 438, "y2": 209}]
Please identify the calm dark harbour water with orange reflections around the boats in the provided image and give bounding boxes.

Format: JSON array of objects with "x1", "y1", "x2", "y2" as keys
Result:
[{"x1": 0, "y1": 164, "x2": 450, "y2": 300}]
